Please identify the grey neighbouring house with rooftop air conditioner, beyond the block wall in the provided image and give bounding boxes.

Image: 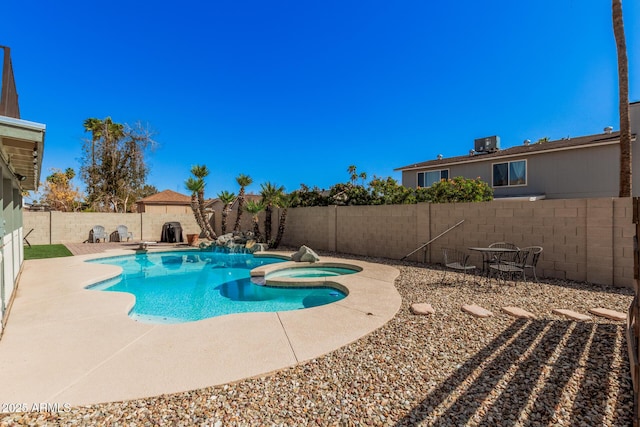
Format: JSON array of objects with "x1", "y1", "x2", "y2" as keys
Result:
[{"x1": 395, "y1": 102, "x2": 640, "y2": 199}]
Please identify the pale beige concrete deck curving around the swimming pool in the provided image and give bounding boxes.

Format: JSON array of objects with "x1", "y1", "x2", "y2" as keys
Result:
[{"x1": 0, "y1": 249, "x2": 401, "y2": 408}]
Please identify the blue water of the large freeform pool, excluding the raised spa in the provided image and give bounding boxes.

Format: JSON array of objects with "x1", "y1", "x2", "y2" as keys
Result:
[{"x1": 89, "y1": 251, "x2": 346, "y2": 323}]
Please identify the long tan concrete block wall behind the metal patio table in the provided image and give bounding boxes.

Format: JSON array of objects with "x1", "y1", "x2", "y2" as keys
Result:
[{"x1": 283, "y1": 198, "x2": 635, "y2": 287}]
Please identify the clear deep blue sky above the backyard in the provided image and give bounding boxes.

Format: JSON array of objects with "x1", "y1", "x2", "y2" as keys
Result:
[{"x1": 0, "y1": 0, "x2": 640, "y2": 197}]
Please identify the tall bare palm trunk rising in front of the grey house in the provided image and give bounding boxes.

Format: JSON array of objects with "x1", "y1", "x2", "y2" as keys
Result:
[{"x1": 611, "y1": 0, "x2": 633, "y2": 197}]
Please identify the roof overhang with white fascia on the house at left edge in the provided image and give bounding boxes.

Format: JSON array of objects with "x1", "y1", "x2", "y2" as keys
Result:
[{"x1": 0, "y1": 116, "x2": 46, "y2": 191}]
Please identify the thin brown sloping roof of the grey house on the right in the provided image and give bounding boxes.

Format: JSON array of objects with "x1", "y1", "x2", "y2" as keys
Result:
[{"x1": 394, "y1": 132, "x2": 635, "y2": 171}]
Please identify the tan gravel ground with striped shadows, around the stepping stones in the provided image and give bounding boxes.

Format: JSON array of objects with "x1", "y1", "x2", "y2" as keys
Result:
[{"x1": 0, "y1": 253, "x2": 633, "y2": 426}]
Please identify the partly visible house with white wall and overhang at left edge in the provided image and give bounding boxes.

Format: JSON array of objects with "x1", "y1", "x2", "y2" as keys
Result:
[{"x1": 0, "y1": 46, "x2": 46, "y2": 332}]
